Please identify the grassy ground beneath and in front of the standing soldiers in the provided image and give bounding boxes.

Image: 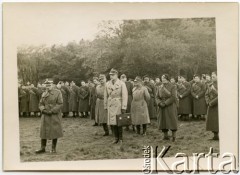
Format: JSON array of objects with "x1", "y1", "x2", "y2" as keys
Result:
[{"x1": 19, "y1": 117, "x2": 219, "y2": 162}]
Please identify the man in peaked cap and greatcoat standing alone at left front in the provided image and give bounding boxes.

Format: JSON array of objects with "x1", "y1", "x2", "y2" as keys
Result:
[{"x1": 35, "y1": 81, "x2": 63, "y2": 154}]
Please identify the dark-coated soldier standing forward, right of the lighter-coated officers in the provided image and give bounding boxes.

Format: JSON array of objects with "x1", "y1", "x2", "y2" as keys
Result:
[{"x1": 156, "y1": 74, "x2": 177, "y2": 142}]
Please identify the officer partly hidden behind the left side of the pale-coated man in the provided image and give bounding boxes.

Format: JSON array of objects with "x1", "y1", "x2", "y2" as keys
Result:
[{"x1": 95, "y1": 74, "x2": 109, "y2": 136}]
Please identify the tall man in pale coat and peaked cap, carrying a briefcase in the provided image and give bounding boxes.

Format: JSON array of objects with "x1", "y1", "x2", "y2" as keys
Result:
[{"x1": 104, "y1": 69, "x2": 128, "y2": 143}]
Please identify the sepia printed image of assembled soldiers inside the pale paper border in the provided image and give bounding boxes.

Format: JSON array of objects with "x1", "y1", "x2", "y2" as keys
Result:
[{"x1": 2, "y1": 3, "x2": 239, "y2": 172}]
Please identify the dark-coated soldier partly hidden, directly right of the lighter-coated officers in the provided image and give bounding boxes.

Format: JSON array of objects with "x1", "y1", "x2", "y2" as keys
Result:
[{"x1": 143, "y1": 75, "x2": 156, "y2": 119}]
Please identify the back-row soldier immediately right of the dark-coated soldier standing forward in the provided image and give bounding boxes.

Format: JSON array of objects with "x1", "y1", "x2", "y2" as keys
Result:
[{"x1": 177, "y1": 76, "x2": 192, "y2": 120}]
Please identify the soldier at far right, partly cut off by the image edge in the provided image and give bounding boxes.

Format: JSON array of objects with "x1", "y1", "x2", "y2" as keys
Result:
[{"x1": 205, "y1": 72, "x2": 219, "y2": 140}]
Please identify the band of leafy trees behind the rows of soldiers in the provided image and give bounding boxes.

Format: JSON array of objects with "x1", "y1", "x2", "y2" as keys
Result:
[{"x1": 17, "y1": 18, "x2": 216, "y2": 84}]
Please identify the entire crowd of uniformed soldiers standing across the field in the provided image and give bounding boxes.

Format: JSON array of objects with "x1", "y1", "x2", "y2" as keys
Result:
[{"x1": 19, "y1": 69, "x2": 219, "y2": 153}]
